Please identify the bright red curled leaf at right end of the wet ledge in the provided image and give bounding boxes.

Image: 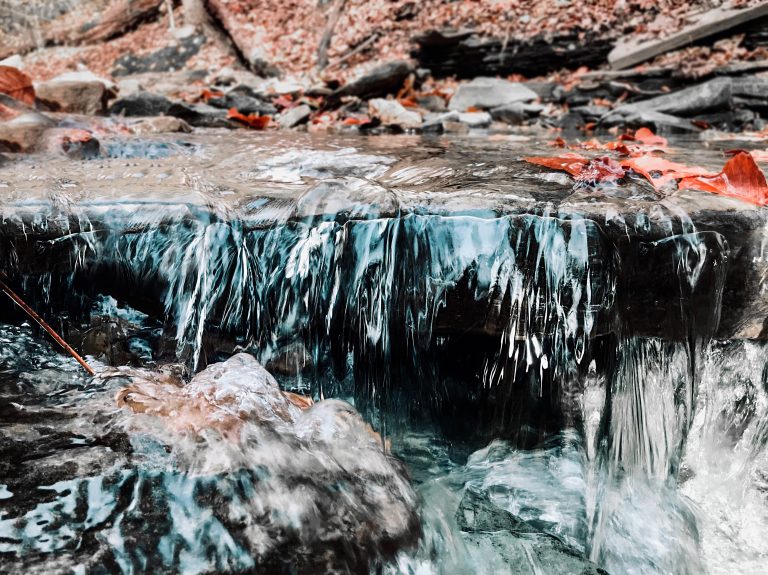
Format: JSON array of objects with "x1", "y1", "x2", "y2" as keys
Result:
[{"x1": 678, "y1": 152, "x2": 768, "y2": 206}]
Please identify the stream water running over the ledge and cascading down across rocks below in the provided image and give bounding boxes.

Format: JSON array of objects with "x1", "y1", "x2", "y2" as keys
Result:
[{"x1": 0, "y1": 133, "x2": 768, "y2": 574}]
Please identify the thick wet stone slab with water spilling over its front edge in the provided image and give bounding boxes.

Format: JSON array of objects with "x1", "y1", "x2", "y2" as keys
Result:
[{"x1": 0, "y1": 130, "x2": 768, "y2": 339}]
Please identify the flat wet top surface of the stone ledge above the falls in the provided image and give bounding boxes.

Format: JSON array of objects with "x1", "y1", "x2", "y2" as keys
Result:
[{"x1": 0, "y1": 130, "x2": 768, "y2": 337}]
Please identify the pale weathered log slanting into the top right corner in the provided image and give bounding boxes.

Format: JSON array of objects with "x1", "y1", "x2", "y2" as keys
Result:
[{"x1": 608, "y1": 2, "x2": 768, "y2": 70}]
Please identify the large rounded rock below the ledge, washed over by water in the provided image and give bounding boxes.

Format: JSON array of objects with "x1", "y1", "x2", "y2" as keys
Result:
[{"x1": 0, "y1": 354, "x2": 419, "y2": 573}]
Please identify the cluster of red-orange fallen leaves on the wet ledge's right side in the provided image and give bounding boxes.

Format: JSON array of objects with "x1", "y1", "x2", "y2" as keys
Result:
[{"x1": 523, "y1": 128, "x2": 768, "y2": 206}]
